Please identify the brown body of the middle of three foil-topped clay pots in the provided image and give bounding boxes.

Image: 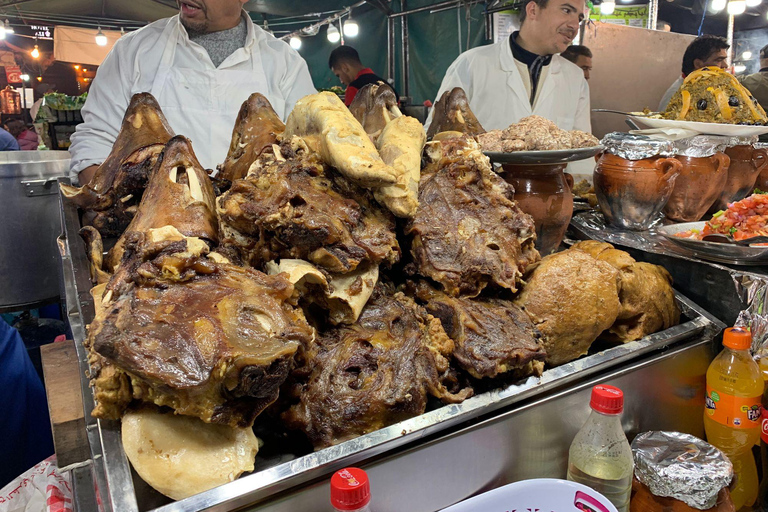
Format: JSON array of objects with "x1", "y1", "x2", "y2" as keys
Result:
[{"x1": 664, "y1": 153, "x2": 731, "y2": 222}]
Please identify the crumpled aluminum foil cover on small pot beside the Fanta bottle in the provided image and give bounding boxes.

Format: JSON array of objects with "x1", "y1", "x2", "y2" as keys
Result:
[{"x1": 632, "y1": 431, "x2": 733, "y2": 510}]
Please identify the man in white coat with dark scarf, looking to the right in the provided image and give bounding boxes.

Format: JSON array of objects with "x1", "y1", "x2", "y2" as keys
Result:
[{"x1": 426, "y1": 0, "x2": 594, "y2": 136}]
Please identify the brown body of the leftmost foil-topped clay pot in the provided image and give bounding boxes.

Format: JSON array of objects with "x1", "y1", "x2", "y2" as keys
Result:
[{"x1": 593, "y1": 153, "x2": 681, "y2": 231}]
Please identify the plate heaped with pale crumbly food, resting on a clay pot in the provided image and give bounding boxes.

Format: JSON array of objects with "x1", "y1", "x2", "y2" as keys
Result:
[{"x1": 477, "y1": 116, "x2": 603, "y2": 164}]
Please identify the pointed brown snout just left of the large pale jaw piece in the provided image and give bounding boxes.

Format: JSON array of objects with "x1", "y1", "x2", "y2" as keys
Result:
[{"x1": 216, "y1": 92, "x2": 285, "y2": 188}]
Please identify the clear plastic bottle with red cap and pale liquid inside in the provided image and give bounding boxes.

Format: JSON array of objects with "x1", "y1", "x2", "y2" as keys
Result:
[{"x1": 568, "y1": 384, "x2": 635, "y2": 512}]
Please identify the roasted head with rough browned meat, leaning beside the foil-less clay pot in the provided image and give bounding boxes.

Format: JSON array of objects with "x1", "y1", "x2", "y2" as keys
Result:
[{"x1": 406, "y1": 136, "x2": 540, "y2": 297}]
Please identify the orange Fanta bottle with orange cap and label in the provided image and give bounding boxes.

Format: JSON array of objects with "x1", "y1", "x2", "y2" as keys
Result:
[{"x1": 704, "y1": 327, "x2": 763, "y2": 510}]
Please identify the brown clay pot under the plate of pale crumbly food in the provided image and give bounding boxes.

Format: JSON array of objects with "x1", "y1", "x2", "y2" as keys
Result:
[{"x1": 501, "y1": 164, "x2": 573, "y2": 256}]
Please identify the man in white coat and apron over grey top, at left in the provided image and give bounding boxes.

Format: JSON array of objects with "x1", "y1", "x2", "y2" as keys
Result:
[{"x1": 69, "y1": 0, "x2": 316, "y2": 185}]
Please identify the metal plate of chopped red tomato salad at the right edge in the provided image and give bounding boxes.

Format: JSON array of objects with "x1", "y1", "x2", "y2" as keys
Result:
[{"x1": 656, "y1": 193, "x2": 768, "y2": 265}]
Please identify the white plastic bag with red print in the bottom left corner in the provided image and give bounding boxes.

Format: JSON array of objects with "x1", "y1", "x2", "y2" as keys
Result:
[{"x1": 0, "y1": 455, "x2": 74, "y2": 512}]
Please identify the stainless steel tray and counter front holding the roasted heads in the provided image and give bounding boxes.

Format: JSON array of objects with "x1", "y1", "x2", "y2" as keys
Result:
[{"x1": 59, "y1": 181, "x2": 723, "y2": 512}]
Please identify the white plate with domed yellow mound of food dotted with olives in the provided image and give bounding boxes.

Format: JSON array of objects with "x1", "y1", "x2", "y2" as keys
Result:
[{"x1": 630, "y1": 67, "x2": 768, "y2": 137}]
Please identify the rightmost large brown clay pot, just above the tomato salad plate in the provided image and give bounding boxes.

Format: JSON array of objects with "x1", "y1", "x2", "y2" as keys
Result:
[{"x1": 710, "y1": 145, "x2": 768, "y2": 213}]
